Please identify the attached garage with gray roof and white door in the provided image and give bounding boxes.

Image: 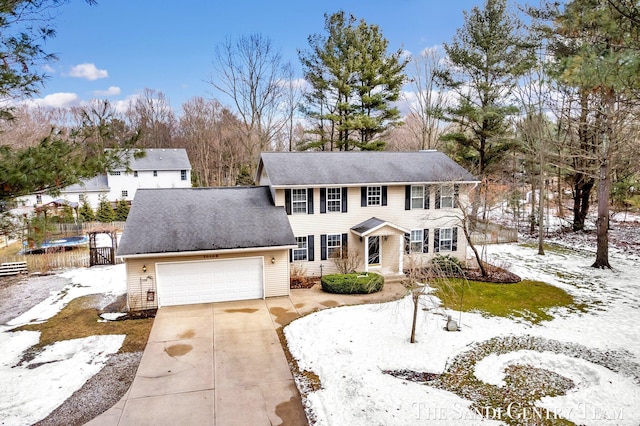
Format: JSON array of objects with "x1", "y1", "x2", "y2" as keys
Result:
[{"x1": 117, "y1": 187, "x2": 297, "y2": 310}]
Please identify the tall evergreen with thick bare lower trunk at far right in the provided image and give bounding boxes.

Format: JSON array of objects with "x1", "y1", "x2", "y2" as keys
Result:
[{"x1": 550, "y1": 0, "x2": 640, "y2": 268}]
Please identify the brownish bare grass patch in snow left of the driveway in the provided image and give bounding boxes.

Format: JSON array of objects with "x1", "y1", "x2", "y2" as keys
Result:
[{"x1": 15, "y1": 294, "x2": 153, "y2": 352}]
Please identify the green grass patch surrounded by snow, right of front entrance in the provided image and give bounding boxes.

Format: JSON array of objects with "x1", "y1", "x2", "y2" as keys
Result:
[{"x1": 435, "y1": 279, "x2": 574, "y2": 324}]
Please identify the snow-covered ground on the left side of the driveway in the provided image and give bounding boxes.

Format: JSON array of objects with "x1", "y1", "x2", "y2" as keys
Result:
[{"x1": 0, "y1": 265, "x2": 126, "y2": 425}]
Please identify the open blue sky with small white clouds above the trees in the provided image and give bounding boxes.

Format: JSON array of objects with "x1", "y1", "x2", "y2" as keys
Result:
[{"x1": 36, "y1": 0, "x2": 482, "y2": 115}]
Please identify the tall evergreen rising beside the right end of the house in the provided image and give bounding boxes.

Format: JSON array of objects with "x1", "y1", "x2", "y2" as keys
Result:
[{"x1": 440, "y1": 0, "x2": 535, "y2": 217}]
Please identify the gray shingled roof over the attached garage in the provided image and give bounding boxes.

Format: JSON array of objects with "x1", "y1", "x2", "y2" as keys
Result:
[{"x1": 118, "y1": 187, "x2": 296, "y2": 256}]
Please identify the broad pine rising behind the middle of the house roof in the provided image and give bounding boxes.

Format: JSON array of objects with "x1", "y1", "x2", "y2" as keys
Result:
[{"x1": 298, "y1": 11, "x2": 408, "y2": 151}]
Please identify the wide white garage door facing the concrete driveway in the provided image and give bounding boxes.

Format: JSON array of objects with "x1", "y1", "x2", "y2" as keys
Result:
[{"x1": 156, "y1": 257, "x2": 264, "y2": 306}]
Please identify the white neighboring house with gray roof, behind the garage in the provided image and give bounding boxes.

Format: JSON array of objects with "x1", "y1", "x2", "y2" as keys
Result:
[{"x1": 18, "y1": 148, "x2": 191, "y2": 209}]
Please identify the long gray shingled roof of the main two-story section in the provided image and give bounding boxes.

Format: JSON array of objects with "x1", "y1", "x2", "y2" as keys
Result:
[{"x1": 258, "y1": 151, "x2": 478, "y2": 186}]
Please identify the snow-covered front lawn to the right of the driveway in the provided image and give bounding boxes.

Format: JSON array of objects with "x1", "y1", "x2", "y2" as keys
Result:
[{"x1": 285, "y1": 241, "x2": 640, "y2": 426}]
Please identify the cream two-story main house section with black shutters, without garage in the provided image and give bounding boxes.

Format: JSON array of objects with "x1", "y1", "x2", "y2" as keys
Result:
[{"x1": 257, "y1": 151, "x2": 477, "y2": 275}]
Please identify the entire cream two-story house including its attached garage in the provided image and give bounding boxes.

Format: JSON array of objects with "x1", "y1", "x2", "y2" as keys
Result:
[{"x1": 118, "y1": 151, "x2": 477, "y2": 309}]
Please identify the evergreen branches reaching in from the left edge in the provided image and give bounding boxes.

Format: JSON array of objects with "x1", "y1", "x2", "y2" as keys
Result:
[{"x1": 0, "y1": 0, "x2": 138, "y2": 201}]
